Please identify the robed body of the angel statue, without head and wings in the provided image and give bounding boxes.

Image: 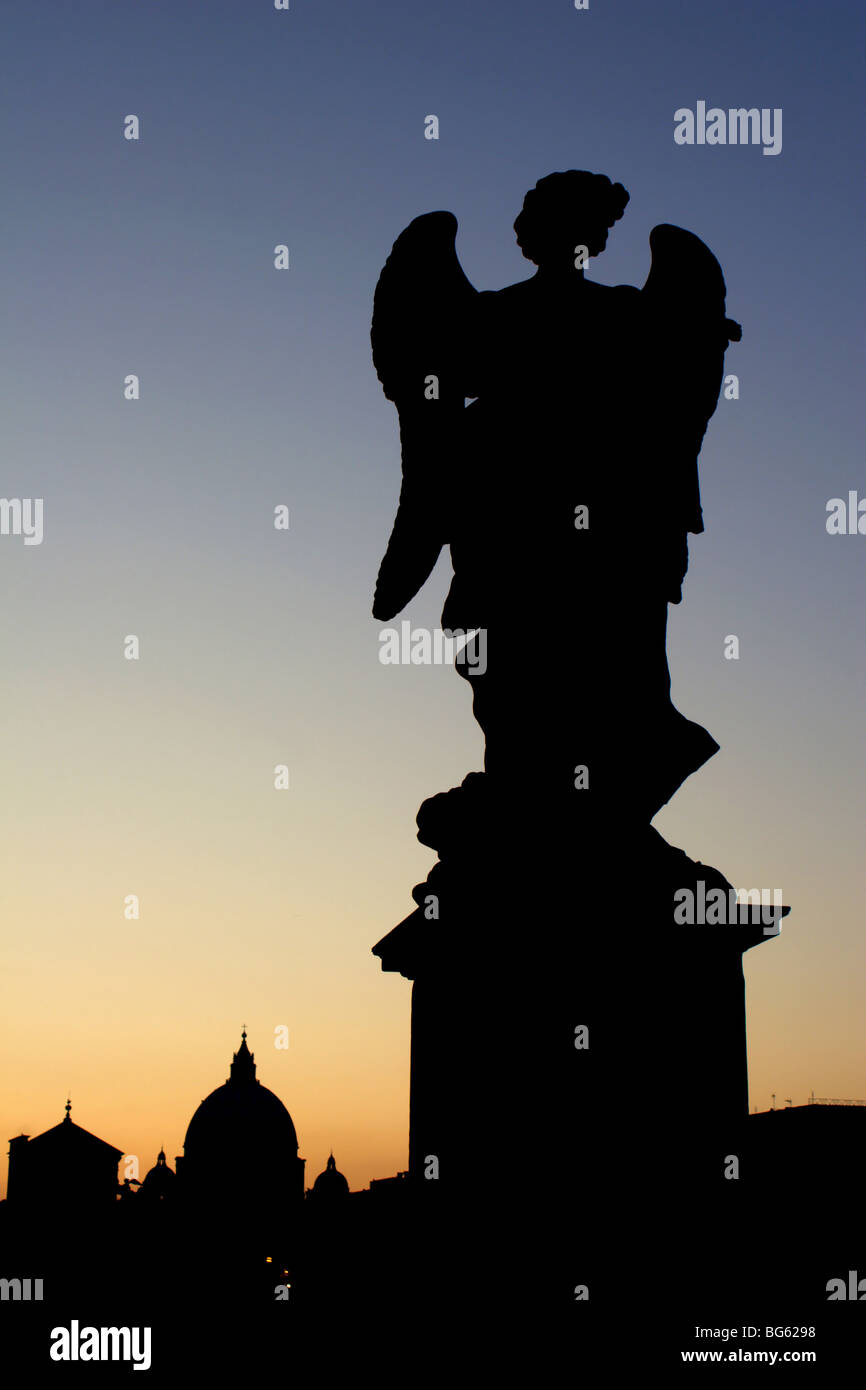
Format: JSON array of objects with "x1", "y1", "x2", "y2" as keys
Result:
[{"x1": 442, "y1": 272, "x2": 717, "y2": 820}]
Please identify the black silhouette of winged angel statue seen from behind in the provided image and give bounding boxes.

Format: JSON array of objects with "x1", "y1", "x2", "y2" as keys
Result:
[{"x1": 371, "y1": 170, "x2": 741, "y2": 823}]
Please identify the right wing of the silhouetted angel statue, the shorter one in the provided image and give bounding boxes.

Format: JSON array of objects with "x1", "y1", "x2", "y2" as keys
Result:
[{"x1": 641, "y1": 224, "x2": 742, "y2": 532}]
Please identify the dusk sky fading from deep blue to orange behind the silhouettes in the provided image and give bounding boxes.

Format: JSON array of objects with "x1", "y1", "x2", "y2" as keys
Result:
[{"x1": 0, "y1": 0, "x2": 866, "y2": 1187}]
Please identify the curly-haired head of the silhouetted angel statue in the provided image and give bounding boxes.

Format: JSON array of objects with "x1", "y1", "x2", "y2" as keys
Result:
[{"x1": 514, "y1": 170, "x2": 628, "y2": 267}]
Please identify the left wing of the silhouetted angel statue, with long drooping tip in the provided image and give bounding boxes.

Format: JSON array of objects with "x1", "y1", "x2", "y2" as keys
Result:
[{"x1": 370, "y1": 213, "x2": 478, "y2": 621}]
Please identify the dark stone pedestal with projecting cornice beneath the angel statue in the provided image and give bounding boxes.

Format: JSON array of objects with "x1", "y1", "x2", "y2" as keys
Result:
[{"x1": 374, "y1": 774, "x2": 787, "y2": 1305}]
